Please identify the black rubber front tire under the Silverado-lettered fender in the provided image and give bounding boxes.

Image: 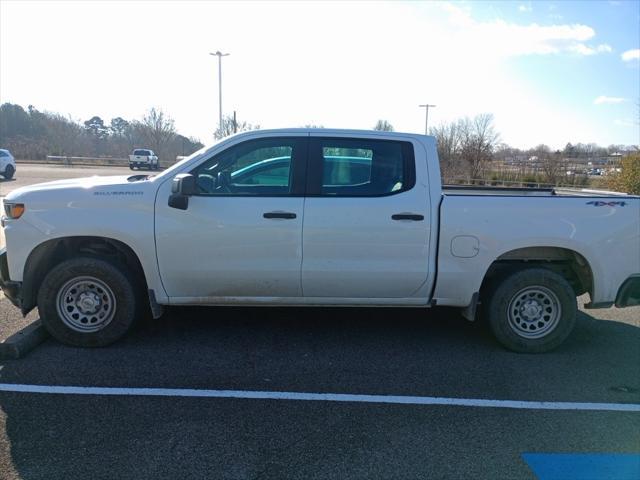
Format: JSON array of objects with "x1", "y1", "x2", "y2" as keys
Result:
[{"x1": 38, "y1": 257, "x2": 140, "y2": 347}]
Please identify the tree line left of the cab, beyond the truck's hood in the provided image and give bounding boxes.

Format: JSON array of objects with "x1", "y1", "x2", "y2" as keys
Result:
[{"x1": 0, "y1": 103, "x2": 203, "y2": 162}]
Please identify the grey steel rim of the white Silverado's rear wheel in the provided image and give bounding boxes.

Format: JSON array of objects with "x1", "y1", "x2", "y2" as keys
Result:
[{"x1": 507, "y1": 285, "x2": 562, "y2": 339}]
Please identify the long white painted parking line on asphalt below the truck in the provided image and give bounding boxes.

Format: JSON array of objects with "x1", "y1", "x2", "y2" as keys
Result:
[{"x1": 0, "y1": 383, "x2": 640, "y2": 412}]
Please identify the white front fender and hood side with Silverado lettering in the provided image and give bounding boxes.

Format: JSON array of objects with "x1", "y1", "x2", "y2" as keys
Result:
[{"x1": 5, "y1": 176, "x2": 166, "y2": 299}]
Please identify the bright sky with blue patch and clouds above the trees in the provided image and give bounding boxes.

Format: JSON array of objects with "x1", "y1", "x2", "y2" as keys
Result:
[{"x1": 0, "y1": 0, "x2": 640, "y2": 148}]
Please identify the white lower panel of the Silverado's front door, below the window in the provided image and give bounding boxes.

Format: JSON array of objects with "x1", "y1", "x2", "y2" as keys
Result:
[{"x1": 156, "y1": 194, "x2": 304, "y2": 299}]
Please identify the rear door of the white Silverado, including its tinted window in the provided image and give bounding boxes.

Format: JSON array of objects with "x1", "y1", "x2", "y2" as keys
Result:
[{"x1": 302, "y1": 134, "x2": 431, "y2": 298}]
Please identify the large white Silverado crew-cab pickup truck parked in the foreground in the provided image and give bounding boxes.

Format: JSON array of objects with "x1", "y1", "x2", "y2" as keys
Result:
[{"x1": 0, "y1": 129, "x2": 640, "y2": 352}]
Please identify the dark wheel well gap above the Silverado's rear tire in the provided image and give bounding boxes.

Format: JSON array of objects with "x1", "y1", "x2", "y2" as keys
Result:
[{"x1": 480, "y1": 247, "x2": 593, "y2": 296}]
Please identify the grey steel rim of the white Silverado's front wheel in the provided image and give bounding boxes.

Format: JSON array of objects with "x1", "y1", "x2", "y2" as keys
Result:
[{"x1": 56, "y1": 276, "x2": 116, "y2": 333}]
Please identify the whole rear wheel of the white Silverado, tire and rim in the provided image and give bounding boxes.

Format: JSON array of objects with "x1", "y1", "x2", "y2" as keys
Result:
[{"x1": 483, "y1": 268, "x2": 577, "y2": 353}]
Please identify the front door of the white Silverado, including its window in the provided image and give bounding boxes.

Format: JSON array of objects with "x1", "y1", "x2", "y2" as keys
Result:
[{"x1": 156, "y1": 134, "x2": 307, "y2": 303}]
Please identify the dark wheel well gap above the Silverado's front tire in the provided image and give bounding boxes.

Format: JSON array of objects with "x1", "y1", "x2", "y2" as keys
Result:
[{"x1": 21, "y1": 236, "x2": 147, "y2": 315}]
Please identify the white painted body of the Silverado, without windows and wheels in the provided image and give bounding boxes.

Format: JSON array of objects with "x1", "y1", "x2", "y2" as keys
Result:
[{"x1": 5, "y1": 129, "x2": 640, "y2": 314}]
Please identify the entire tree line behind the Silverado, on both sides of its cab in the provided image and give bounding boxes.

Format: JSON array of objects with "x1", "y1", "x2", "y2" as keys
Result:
[{"x1": 0, "y1": 103, "x2": 640, "y2": 193}]
